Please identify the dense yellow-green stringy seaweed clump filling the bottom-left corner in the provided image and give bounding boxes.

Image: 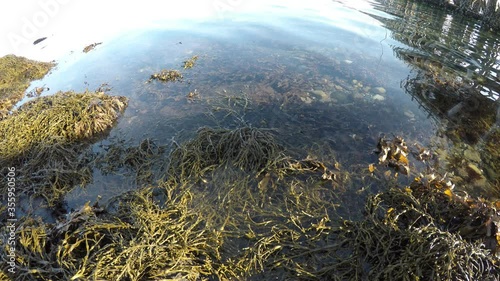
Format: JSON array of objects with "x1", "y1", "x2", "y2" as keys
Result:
[{"x1": 2, "y1": 185, "x2": 218, "y2": 280}]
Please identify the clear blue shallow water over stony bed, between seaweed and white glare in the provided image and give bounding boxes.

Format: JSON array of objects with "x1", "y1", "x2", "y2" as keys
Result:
[{"x1": 13, "y1": 0, "x2": 500, "y2": 208}]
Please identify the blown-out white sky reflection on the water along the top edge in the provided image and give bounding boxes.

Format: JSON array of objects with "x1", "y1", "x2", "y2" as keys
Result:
[{"x1": 0, "y1": 0, "x2": 394, "y2": 60}]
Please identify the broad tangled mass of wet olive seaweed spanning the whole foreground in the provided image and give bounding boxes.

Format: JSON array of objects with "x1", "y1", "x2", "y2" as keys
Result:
[{"x1": 2, "y1": 127, "x2": 500, "y2": 280}]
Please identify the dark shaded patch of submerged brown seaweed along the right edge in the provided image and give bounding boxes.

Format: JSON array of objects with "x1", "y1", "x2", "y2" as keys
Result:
[{"x1": 398, "y1": 47, "x2": 500, "y2": 196}]
